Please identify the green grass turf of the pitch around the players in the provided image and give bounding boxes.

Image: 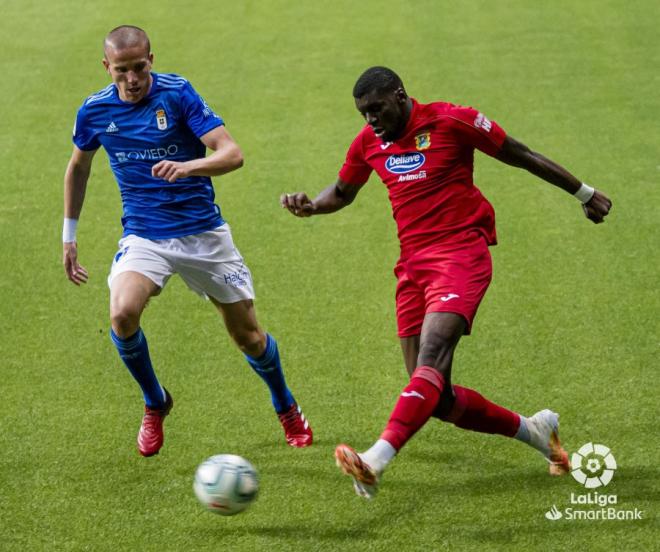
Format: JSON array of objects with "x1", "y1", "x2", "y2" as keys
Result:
[{"x1": 0, "y1": 0, "x2": 660, "y2": 551}]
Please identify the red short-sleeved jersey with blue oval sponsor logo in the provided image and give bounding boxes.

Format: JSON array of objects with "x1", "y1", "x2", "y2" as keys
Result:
[{"x1": 339, "y1": 99, "x2": 506, "y2": 258}]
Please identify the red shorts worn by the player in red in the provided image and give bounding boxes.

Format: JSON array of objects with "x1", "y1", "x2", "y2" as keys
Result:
[{"x1": 394, "y1": 234, "x2": 493, "y2": 337}]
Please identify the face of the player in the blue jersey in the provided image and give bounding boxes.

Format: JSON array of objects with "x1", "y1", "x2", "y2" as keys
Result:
[{"x1": 103, "y1": 46, "x2": 154, "y2": 103}]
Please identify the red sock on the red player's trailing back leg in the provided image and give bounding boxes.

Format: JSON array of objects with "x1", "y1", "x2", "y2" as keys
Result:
[{"x1": 440, "y1": 385, "x2": 520, "y2": 437}]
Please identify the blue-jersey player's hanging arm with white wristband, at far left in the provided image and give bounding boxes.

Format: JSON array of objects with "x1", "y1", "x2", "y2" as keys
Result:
[{"x1": 62, "y1": 146, "x2": 97, "y2": 286}]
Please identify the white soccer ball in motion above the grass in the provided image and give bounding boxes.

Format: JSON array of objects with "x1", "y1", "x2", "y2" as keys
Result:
[{"x1": 193, "y1": 454, "x2": 259, "y2": 516}]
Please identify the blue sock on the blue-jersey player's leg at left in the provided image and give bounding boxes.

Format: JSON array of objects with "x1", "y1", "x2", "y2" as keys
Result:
[{"x1": 110, "y1": 328, "x2": 165, "y2": 408}]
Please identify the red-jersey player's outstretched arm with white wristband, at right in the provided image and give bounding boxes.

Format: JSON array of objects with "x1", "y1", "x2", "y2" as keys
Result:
[{"x1": 495, "y1": 136, "x2": 612, "y2": 224}]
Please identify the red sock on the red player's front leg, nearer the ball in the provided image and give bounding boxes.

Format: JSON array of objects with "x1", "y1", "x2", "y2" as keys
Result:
[{"x1": 380, "y1": 366, "x2": 445, "y2": 450}]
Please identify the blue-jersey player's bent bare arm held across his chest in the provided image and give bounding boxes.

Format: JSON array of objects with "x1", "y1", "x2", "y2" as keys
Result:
[{"x1": 151, "y1": 125, "x2": 243, "y2": 182}]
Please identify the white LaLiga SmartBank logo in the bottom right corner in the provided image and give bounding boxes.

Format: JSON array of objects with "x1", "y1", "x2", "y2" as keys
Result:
[{"x1": 545, "y1": 443, "x2": 644, "y2": 521}]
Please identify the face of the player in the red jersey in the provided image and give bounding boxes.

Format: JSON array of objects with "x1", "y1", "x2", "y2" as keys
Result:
[{"x1": 355, "y1": 88, "x2": 410, "y2": 142}]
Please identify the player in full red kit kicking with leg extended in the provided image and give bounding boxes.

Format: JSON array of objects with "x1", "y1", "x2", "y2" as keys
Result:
[{"x1": 280, "y1": 67, "x2": 612, "y2": 498}]
